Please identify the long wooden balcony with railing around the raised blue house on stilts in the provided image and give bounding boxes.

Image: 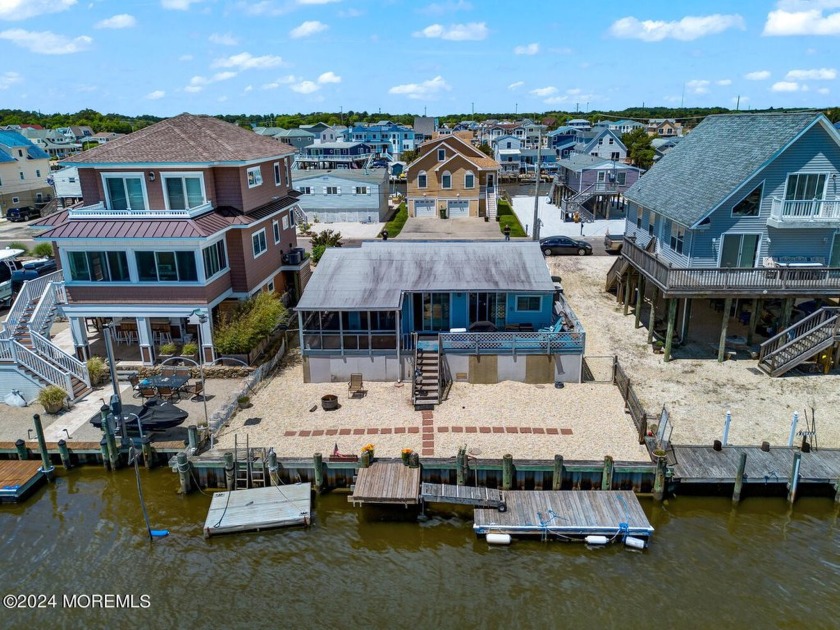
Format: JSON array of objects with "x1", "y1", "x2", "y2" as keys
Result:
[{"x1": 621, "y1": 239, "x2": 840, "y2": 298}]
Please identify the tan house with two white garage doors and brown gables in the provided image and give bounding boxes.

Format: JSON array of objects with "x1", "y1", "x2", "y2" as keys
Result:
[{"x1": 406, "y1": 135, "x2": 502, "y2": 219}]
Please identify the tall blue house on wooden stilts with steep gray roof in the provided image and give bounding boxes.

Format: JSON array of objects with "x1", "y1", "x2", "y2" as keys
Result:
[{"x1": 608, "y1": 112, "x2": 840, "y2": 375}]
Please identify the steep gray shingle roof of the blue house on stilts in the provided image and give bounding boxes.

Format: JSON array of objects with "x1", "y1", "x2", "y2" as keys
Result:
[{"x1": 624, "y1": 112, "x2": 829, "y2": 226}]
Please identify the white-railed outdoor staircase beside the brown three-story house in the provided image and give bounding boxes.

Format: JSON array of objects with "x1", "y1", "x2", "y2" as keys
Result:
[{"x1": 0, "y1": 271, "x2": 91, "y2": 402}]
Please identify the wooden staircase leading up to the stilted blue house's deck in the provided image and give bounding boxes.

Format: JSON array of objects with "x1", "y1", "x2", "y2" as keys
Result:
[{"x1": 758, "y1": 307, "x2": 840, "y2": 376}]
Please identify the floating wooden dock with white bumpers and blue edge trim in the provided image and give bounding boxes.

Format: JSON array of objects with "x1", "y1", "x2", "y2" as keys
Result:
[{"x1": 473, "y1": 490, "x2": 653, "y2": 538}]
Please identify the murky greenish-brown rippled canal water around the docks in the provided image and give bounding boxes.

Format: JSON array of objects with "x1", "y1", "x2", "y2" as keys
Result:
[{"x1": 0, "y1": 467, "x2": 840, "y2": 628}]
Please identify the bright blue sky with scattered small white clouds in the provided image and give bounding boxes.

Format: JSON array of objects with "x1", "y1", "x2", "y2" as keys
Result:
[{"x1": 0, "y1": 0, "x2": 840, "y2": 116}]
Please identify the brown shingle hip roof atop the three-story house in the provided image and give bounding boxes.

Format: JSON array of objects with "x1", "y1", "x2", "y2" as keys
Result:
[{"x1": 63, "y1": 114, "x2": 294, "y2": 166}]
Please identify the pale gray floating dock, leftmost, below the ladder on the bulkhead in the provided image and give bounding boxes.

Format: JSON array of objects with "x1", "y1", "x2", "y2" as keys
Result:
[{"x1": 204, "y1": 483, "x2": 312, "y2": 538}]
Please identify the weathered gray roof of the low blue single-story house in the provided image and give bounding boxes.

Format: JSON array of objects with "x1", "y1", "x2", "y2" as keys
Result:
[{"x1": 297, "y1": 241, "x2": 554, "y2": 311}]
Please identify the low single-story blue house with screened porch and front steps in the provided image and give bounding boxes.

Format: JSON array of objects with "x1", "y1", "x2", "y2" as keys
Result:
[{"x1": 296, "y1": 241, "x2": 585, "y2": 404}]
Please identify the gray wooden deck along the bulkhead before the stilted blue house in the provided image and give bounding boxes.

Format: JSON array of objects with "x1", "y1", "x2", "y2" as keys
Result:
[{"x1": 672, "y1": 446, "x2": 840, "y2": 484}]
